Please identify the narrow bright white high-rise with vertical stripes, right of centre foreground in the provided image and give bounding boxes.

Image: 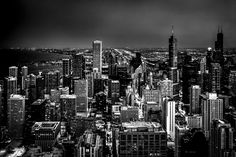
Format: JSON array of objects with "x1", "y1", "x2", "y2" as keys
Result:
[{"x1": 162, "y1": 97, "x2": 175, "y2": 140}]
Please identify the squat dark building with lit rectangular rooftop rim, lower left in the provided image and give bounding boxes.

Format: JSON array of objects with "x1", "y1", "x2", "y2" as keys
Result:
[{"x1": 32, "y1": 122, "x2": 61, "y2": 151}]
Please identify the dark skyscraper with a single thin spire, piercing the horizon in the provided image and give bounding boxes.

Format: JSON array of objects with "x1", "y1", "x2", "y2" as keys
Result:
[{"x1": 169, "y1": 26, "x2": 177, "y2": 67}]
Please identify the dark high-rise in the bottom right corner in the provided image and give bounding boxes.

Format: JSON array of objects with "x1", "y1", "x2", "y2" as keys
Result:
[{"x1": 210, "y1": 120, "x2": 236, "y2": 157}]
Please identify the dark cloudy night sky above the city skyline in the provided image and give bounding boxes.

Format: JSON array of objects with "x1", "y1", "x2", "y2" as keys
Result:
[{"x1": 0, "y1": 0, "x2": 236, "y2": 48}]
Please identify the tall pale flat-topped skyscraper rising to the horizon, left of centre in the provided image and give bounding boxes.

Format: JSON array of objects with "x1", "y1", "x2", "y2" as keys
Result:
[{"x1": 93, "y1": 40, "x2": 102, "y2": 72}]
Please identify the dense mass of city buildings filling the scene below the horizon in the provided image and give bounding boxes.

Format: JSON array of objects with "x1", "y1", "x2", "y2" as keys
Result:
[{"x1": 0, "y1": 27, "x2": 236, "y2": 157}]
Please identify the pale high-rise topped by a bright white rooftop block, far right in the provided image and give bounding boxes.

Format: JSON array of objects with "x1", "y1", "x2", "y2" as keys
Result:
[{"x1": 201, "y1": 93, "x2": 223, "y2": 138}]
